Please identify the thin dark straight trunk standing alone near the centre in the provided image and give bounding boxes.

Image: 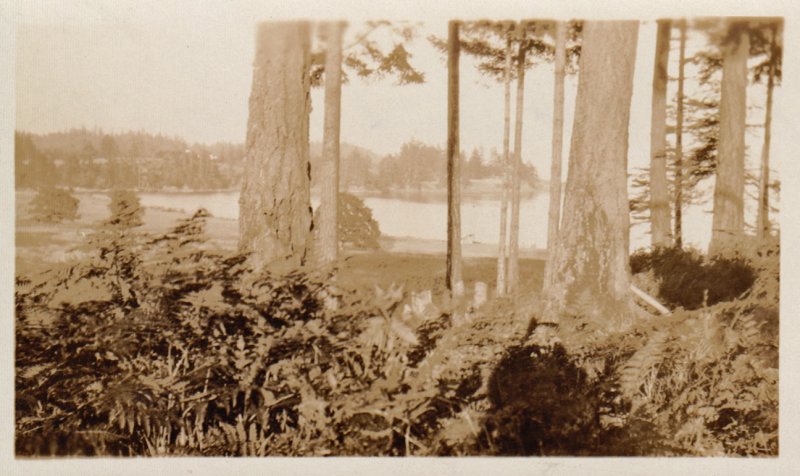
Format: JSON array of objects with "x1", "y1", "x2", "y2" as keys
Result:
[{"x1": 446, "y1": 21, "x2": 464, "y2": 295}]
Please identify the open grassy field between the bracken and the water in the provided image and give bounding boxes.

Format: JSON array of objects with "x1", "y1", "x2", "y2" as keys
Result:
[{"x1": 16, "y1": 190, "x2": 545, "y2": 292}]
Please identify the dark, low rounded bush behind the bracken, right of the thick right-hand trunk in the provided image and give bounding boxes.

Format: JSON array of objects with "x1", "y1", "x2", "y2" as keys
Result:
[{"x1": 630, "y1": 248, "x2": 755, "y2": 309}]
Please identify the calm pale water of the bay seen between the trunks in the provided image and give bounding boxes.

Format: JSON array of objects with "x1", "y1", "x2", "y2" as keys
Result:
[{"x1": 139, "y1": 191, "x2": 711, "y2": 249}]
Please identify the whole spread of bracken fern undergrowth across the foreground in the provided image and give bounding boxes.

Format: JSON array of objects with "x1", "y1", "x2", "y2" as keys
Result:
[{"x1": 15, "y1": 206, "x2": 779, "y2": 456}]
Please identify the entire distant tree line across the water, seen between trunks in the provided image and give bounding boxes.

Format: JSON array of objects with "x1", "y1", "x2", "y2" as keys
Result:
[{"x1": 14, "y1": 129, "x2": 538, "y2": 192}]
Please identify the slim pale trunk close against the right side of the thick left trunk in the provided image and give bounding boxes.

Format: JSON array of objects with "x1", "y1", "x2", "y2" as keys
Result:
[{"x1": 319, "y1": 21, "x2": 344, "y2": 265}]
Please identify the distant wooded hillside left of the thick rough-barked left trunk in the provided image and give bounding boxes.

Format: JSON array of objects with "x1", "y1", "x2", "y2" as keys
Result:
[{"x1": 14, "y1": 129, "x2": 243, "y2": 190}]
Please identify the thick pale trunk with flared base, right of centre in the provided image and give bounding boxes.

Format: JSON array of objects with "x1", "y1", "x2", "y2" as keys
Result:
[{"x1": 540, "y1": 21, "x2": 639, "y2": 326}]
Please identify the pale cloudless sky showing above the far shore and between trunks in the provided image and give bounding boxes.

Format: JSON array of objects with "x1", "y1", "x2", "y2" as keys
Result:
[{"x1": 16, "y1": 1, "x2": 785, "y2": 185}]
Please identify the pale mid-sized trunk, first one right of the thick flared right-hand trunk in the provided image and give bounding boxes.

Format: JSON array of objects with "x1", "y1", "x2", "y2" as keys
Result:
[{"x1": 650, "y1": 20, "x2": 672, "y2": 248}]
